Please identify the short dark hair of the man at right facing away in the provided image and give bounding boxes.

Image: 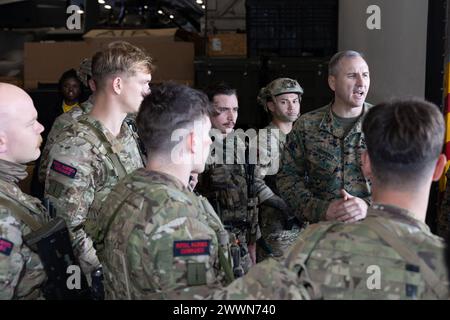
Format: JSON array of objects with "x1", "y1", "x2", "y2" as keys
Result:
[{"x1": 363, "y1": 99, "x2": 445, "y2": 190}]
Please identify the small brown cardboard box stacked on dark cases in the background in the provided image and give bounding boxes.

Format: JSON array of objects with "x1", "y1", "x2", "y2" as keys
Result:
[{"x1": 208, "y1": 33, "x2": 247, "y2": 57}]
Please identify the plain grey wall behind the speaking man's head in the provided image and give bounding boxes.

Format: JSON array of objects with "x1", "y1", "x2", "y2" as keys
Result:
[{"x1": 338, "y1": 0, "x2": 428, "y2": 103}]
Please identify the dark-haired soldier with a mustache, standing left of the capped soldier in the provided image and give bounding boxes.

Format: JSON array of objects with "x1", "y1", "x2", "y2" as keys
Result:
[{"x1": 197, "y1": 83, "x2": 287, "y2": 277}]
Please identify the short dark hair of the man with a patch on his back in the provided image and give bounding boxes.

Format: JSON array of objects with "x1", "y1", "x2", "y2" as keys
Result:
[{"x1": 136, "y1": 82, "x2": 211, "y2": 155}]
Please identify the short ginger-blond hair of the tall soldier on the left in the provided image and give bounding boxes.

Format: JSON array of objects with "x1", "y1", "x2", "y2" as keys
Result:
[{"x1": 92, "y1": 41, "x2": 154, "y2": 87}]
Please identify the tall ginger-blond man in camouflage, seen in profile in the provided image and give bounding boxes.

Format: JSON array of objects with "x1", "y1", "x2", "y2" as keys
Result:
[{"x1": 45, "y1": 41, "x2": 152, "y2": 282}]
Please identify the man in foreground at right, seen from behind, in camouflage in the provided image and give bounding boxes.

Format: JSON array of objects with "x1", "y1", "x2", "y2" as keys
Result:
[{"x1": 211, "y1": 99, "x2": 449, "y2": 299}]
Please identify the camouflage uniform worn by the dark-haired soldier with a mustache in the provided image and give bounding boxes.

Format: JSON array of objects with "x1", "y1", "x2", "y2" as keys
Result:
[{"x1": 196, "y1": 133, "x2": 274, "y2": 273}]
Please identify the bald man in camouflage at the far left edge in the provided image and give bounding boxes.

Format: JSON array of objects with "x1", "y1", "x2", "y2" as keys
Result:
[{"x1": 0, "y1": 83, "x2": 48, "y2": 300}]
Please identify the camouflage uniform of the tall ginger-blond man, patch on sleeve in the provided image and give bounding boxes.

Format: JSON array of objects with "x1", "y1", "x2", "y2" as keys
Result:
[{"x1": 45, "y1": 115, "x2": 144, "y2": 273}]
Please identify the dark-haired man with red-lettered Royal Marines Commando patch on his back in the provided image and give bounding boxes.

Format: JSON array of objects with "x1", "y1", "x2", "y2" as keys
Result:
[{"x1": 91, "y1": 83, "x2": 233, "y2": 299}]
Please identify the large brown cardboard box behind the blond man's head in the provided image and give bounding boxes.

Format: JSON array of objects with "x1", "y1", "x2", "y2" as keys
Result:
[{"x1": 24, "y1": 29, "x2": 194, "y2": 89}]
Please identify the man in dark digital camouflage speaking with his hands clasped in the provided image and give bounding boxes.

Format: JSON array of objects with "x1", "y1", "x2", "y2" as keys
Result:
[{"x1": 277, "y1": 51, "x2": 371, "y2": 222}]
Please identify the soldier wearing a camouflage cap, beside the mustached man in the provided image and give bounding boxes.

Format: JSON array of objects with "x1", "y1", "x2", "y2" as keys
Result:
[{"x1": 257, "y1": 78, "x2": 303, "y2": 261}]
